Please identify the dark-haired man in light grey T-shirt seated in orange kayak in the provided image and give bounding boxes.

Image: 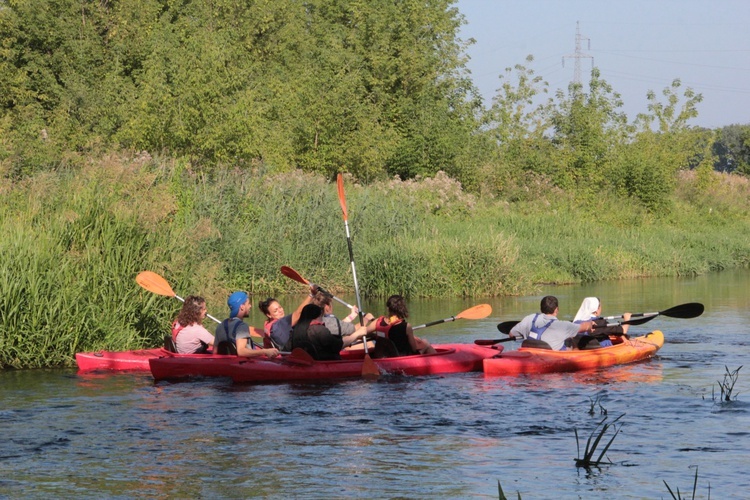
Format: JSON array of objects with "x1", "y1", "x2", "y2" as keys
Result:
[{"x1": 510, "y1": 295, "x2": 592, "y2": 351}]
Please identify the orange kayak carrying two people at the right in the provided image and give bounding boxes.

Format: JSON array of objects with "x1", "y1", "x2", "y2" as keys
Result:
[{"x1": 483, "y1": 330, "x2": 664, "y2": 376}]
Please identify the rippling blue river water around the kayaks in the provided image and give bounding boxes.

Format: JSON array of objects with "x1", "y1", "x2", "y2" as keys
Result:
[{"x1": 0, "y1": 271, "x2": 750, "y2": 499}]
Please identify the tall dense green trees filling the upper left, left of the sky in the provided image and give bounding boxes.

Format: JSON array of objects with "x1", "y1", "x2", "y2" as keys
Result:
[{"x1": 0, "y1": 0, "x2": 479, "y2": 179}]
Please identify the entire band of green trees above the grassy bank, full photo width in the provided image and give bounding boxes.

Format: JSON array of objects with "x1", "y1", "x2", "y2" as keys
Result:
[{"x1": 0, "y1": 0, "x2": 750, "y2": 208}]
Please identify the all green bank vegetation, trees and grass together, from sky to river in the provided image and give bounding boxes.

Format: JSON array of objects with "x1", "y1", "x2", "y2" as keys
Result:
[{"x1": 0, "y1": 0, "x2": 750, "y2": 367}]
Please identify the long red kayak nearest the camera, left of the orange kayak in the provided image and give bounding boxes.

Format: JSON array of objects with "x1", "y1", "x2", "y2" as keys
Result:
[{"x1": 149, "y1": 344, "x2": 502, "y2": 382}]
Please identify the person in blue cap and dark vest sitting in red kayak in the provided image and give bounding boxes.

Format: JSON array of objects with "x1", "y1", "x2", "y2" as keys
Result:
[{"x1": 216, "y1": 291, "x2": 279, "y2": 358}]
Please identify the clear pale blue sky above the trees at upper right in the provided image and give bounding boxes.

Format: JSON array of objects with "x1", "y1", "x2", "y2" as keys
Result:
[{"x1": 455, "y1": 0, "x2": 750, "y2": 128}]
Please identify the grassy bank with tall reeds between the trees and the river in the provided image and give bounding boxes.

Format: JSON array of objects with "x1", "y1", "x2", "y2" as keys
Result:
[{"x1": 0, "y1": 155, "x2": 750, "y2": 368}]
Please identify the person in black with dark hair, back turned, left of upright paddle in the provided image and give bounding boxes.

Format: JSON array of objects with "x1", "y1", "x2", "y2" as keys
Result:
[{"x1": 284, "y1": 304, "x2": 367, "y2": 361}]
